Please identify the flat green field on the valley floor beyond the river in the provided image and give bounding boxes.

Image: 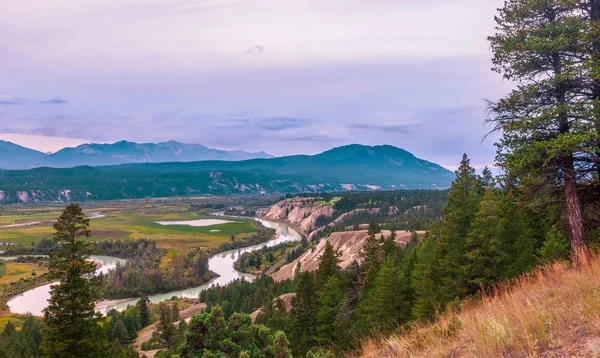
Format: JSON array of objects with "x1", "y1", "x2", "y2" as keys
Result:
[{"x1": 0, "y1": 205, "x2": 256, "y2": 258}]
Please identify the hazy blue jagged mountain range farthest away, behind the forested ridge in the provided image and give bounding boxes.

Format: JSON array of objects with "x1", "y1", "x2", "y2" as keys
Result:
[{"x1": 0, "y1": 141, "x2": 273, "y2": 169}]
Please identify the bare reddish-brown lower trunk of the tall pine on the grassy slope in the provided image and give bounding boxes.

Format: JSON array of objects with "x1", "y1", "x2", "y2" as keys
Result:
[{"x1": 563, "y1": 157, "x2": 588, "y2": 267}]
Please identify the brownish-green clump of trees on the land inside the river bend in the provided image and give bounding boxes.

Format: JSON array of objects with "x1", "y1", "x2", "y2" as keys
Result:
[{"x1": 103, "y1": 239, "x2": 212, "y2": 298}]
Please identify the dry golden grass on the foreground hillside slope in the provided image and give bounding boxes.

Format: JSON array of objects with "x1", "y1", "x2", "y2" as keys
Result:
[{"x1": 361, "y1": 257, "x2": 600, "y2": 357}]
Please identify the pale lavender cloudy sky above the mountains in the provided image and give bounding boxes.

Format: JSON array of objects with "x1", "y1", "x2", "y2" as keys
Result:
[{"x1": 0, "y1": 0, "x2": 511, "y2": 168}]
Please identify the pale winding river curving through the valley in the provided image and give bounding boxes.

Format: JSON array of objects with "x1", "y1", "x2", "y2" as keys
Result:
[{"x1": 8, "y1": 219, "x2": 301, "y2": 316}]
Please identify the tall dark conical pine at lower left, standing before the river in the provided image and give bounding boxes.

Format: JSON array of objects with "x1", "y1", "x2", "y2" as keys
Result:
[{"x1": 42, "y1": 204, "x2": 109, "y2": 357}]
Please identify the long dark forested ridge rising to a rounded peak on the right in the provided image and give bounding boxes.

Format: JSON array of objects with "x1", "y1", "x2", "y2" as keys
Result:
[{"x1": 0, "y1": 144, "x2": 454, "y2": 203}]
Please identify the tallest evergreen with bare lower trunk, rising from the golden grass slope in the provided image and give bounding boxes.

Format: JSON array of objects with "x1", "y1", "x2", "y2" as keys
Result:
[{"x1": 489, "y1": 0, "x2": 600, "y2": 265}]
